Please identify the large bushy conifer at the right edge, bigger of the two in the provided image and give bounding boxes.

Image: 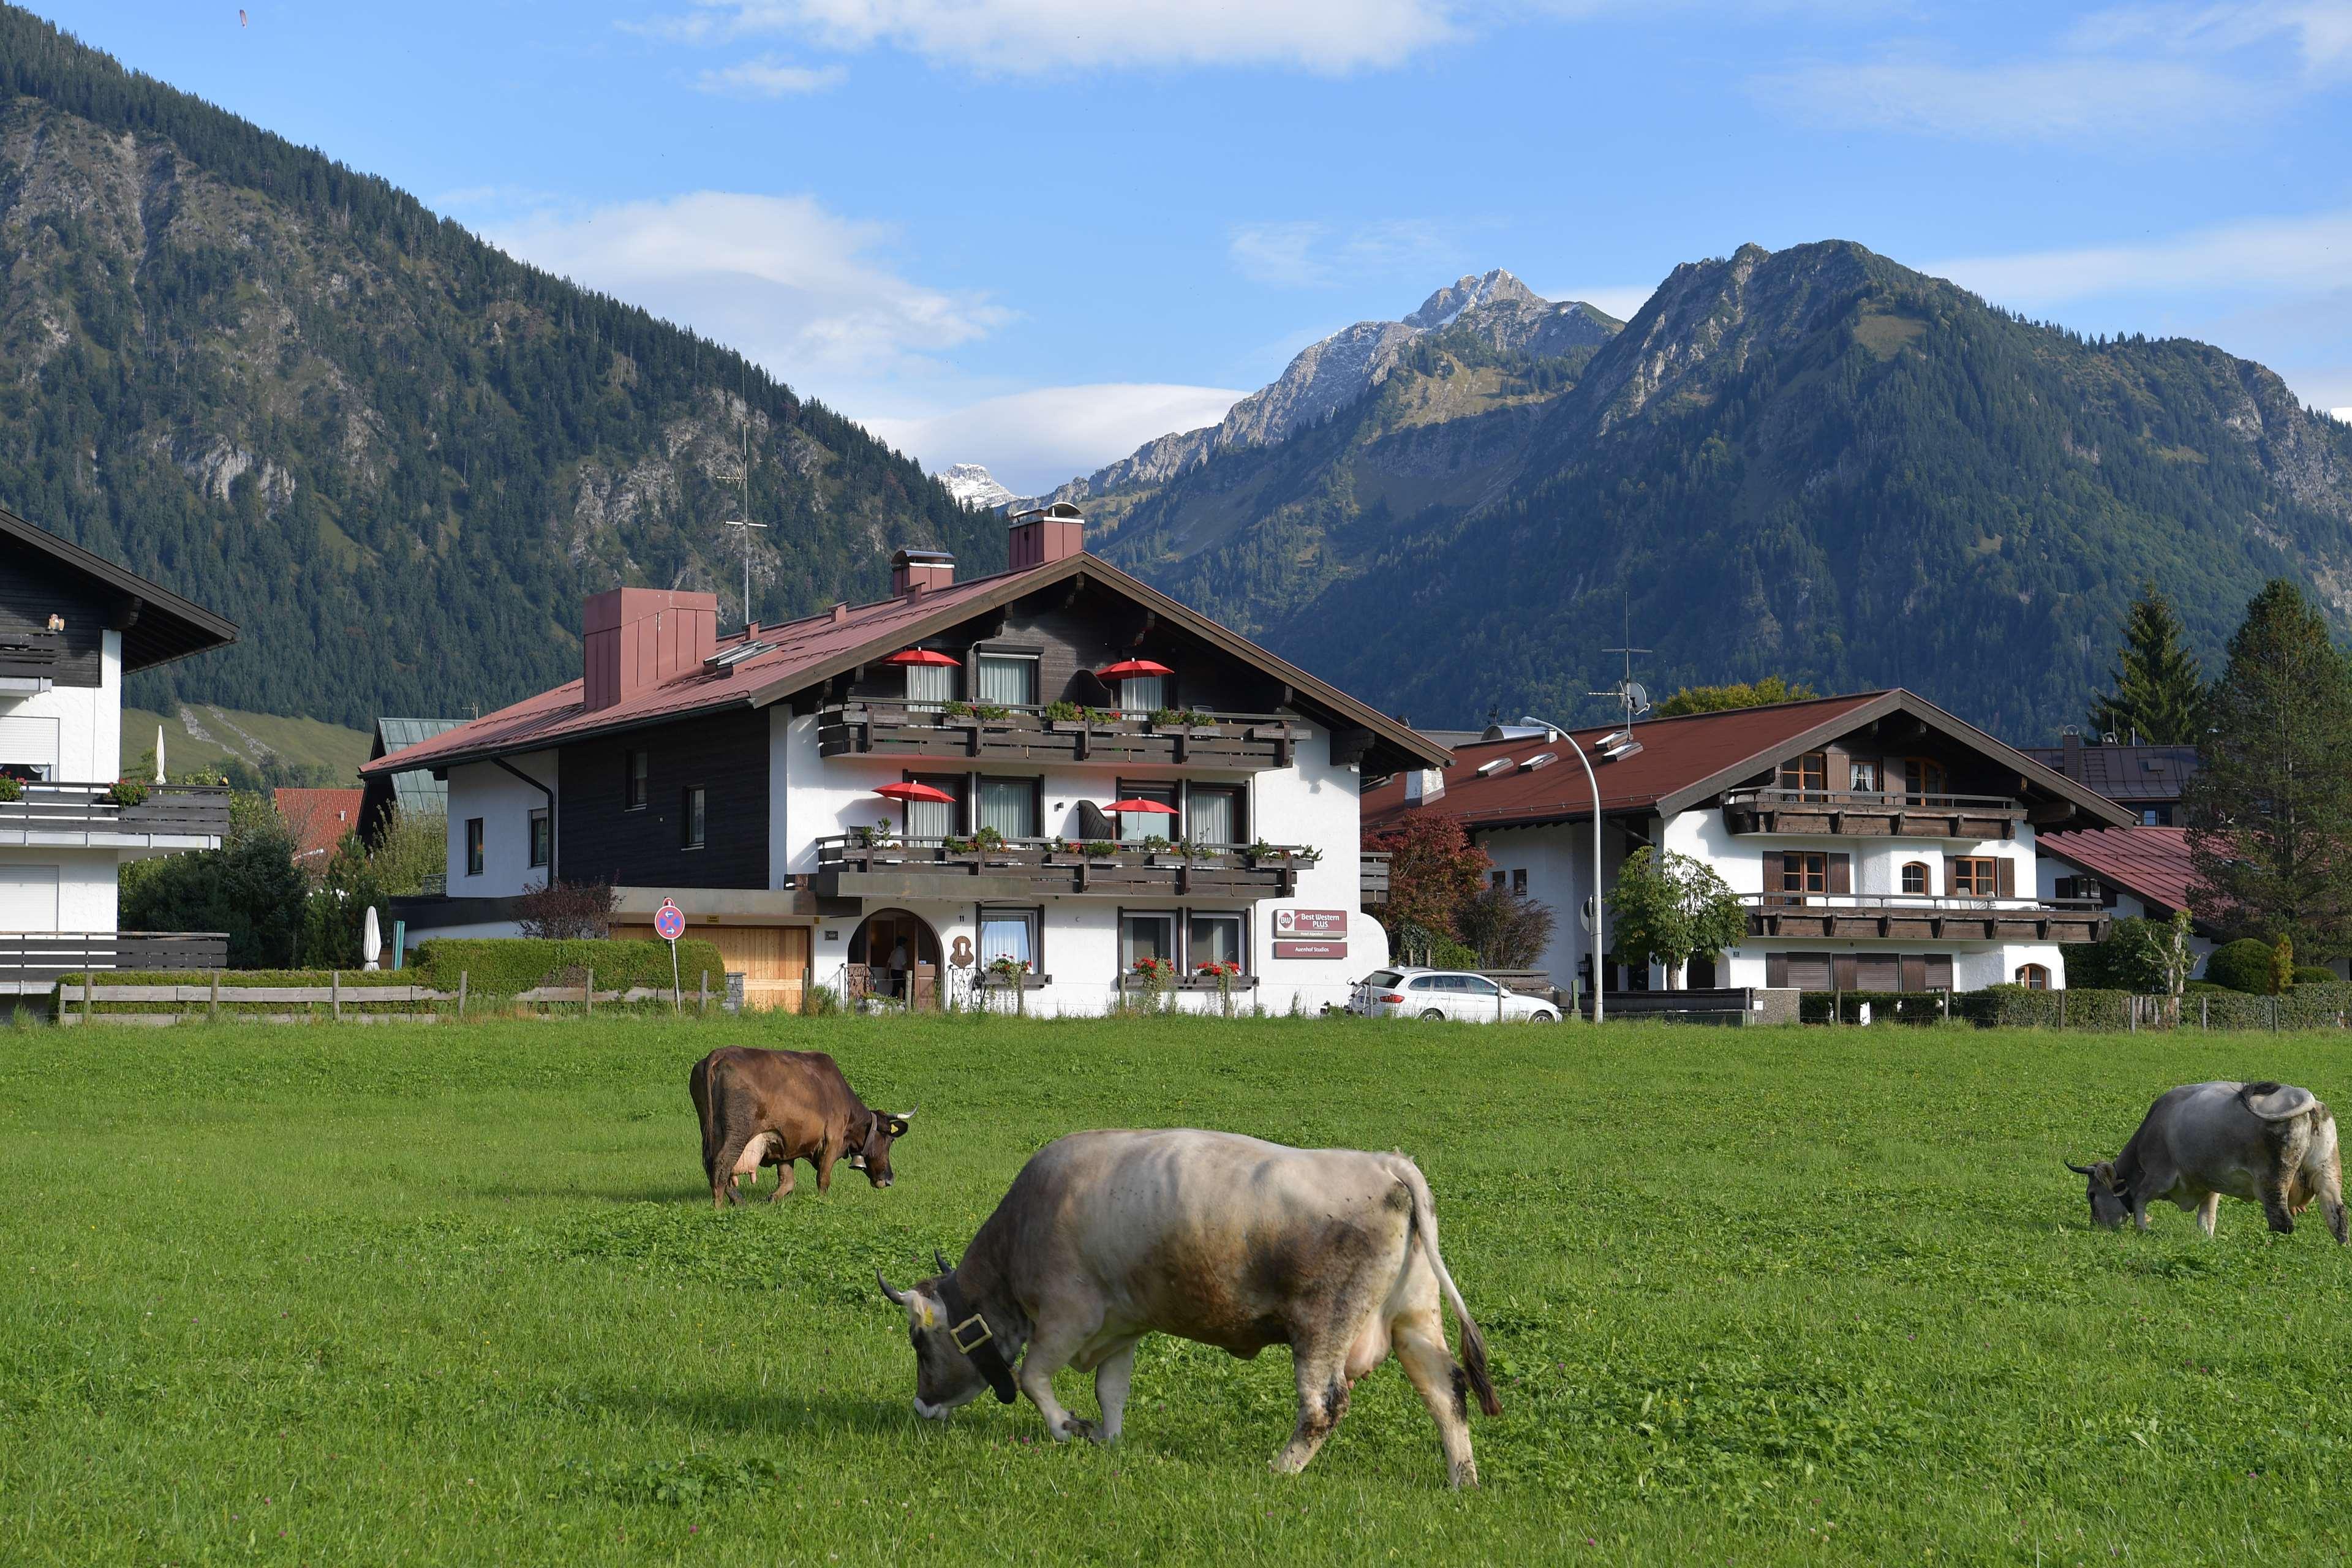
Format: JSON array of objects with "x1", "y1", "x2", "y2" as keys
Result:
[{"x1": 2187, "y1": 578, "x2": 2352, "y2": 959}]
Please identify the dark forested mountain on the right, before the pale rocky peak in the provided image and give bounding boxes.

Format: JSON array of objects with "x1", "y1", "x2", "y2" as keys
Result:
[{"x1": 1091, "y1": 242, "x2": 2352, "y2": 738}]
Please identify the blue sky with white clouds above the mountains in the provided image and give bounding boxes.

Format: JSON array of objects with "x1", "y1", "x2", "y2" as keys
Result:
[{"x1": 36, "y1": 0, "x2": 2352, "y2": 489}]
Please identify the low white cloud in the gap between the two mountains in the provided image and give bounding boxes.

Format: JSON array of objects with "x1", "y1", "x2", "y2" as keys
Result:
[{"x1": 861, "y1": 383, "x2": 1244, "y2": 496}]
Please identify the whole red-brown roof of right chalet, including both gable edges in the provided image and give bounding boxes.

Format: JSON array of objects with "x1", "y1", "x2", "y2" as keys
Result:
[{"x1": 1364, "y1": 689, "x2": 2131, "y2": 827}]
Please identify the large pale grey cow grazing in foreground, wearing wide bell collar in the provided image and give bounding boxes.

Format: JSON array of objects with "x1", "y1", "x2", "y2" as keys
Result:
[{"x1": 875, "y1": 1131, "x2": 1501, "y2": 1486}]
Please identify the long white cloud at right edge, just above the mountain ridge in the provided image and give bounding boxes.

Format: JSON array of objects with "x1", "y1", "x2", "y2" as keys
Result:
[{"x1": 1926, "y1": 211, "x2": 2352, "y2": 306}]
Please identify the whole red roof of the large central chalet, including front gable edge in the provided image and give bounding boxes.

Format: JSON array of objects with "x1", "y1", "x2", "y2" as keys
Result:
[{"x1": 360, "y1": 552, "x2": 1447, "y2": 778}]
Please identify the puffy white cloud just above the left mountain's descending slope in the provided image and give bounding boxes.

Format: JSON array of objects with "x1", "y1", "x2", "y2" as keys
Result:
[{"x1": 489, "y1": 190, "x2": 1011, "y2": 385}]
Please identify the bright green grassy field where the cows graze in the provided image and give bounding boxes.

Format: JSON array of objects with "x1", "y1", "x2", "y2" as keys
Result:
[{"x1": 0, "y1": 1018, "x2": 2352, "y2": 1563}]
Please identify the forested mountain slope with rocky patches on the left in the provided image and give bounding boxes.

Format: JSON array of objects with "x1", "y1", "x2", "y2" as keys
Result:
[{"x1": 0, "y1": 5, "x2": 1005, "y2": 724}]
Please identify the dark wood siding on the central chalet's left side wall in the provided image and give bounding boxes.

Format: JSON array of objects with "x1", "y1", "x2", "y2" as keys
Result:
[{"x1": 555, "y1": 710, "x2": 769, "y2": 889}]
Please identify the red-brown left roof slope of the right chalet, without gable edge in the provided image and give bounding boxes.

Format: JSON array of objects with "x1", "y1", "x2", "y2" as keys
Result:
[{"x1": 1364, "y1": 691, "x2": 1882, "y2": 827}]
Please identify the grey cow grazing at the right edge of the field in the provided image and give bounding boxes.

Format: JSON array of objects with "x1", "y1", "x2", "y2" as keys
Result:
[{"x1": 2067, "y1": 1082, "x2": 2347, "y2": 1243}]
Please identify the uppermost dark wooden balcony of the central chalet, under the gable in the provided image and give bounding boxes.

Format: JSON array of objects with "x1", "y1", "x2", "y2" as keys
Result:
[{"x1": 816, "y1": 703, "x2": 1303, "y2": 771}]
